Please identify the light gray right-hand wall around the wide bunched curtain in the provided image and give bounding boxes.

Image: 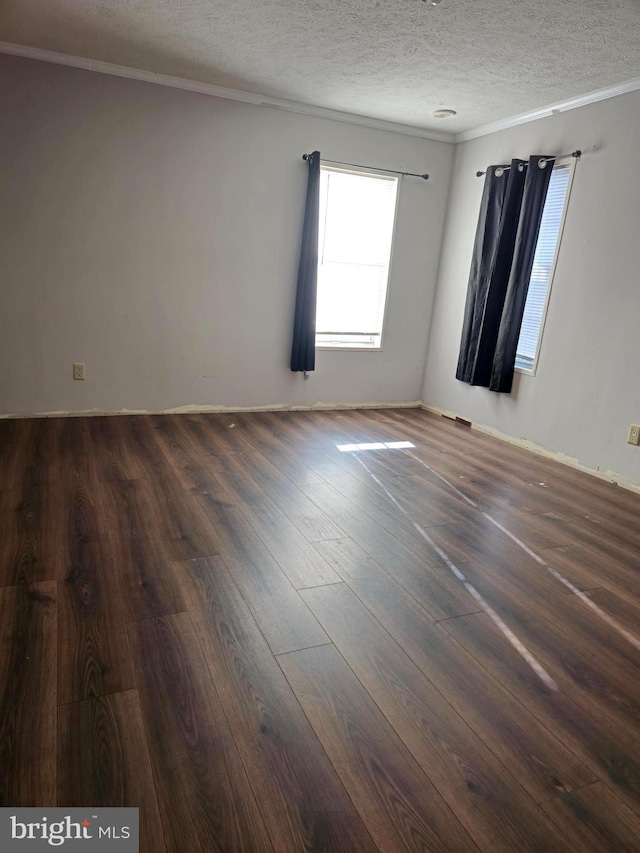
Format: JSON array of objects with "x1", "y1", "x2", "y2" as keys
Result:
[{"x1": 423, "y1": 92, "x2": 640, "y2": 484}]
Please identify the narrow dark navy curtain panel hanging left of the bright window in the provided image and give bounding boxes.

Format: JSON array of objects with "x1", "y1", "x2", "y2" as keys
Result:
[{"x1": 291, "y1": 151, "x2": 320, "y2": 373}]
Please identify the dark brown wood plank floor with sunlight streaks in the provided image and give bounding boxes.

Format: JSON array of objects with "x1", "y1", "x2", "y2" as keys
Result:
[{"x1": 0, "y1": 409, "x2": 640, "y2": 853}]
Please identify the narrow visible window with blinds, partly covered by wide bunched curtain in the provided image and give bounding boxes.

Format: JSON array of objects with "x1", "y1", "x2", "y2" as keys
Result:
[{"x1": 516, "y1": 160, "x2": 573, "y2": 373}]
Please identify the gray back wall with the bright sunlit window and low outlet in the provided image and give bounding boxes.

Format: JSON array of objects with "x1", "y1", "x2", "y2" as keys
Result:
[{"x1": 0, "y1": 56, "x2": 453, "y2": 414}]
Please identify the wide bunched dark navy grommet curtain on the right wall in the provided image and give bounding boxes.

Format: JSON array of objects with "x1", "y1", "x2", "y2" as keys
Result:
[{"x1": 456, "y1": 155, "x2": 553, "y2": 392}]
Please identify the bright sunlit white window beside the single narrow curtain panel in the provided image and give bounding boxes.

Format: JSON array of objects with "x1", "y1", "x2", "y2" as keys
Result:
[{"x1": 316, "y1": 166, "x2": 398, "y2": 349}]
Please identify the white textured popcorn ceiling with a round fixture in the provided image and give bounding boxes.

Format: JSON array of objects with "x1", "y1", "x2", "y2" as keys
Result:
[{"x1": 0, "y1": 0, "x2": 640, "y2": 133}]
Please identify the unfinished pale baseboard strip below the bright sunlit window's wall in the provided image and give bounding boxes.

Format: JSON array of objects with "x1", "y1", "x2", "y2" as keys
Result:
[{"x1": 0, "y1": 400, "x2": 422, "y2": 420}]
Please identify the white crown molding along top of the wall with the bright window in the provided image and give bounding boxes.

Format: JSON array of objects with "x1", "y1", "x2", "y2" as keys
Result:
[{"x1": 0, "y1": 42, "x2": 454, "y2": 143}]
